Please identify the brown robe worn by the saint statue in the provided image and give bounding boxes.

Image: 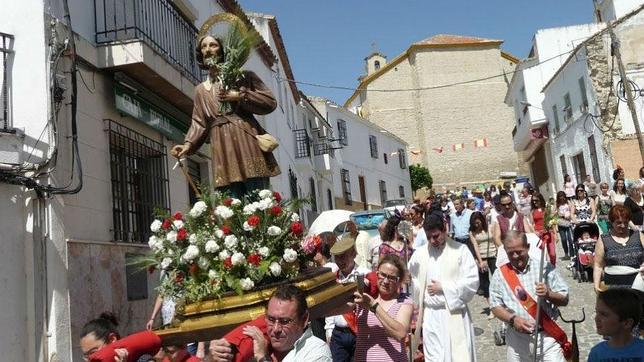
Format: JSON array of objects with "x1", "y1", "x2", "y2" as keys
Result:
[{"x1": 185, "y1": 71, "x2": 280, "y2": 188}]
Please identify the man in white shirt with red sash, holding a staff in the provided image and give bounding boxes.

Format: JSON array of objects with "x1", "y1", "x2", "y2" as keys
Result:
[{"x1": 490, "y1": 231, "x2": 571, "y2": 362}]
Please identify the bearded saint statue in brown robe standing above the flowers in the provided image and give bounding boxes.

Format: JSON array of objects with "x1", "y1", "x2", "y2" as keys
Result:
[{"x1": 170, "y1": 35, "x2": 280, "y2": 197}]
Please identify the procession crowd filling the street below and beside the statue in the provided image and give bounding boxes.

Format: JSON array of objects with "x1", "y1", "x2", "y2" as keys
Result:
[{"x1": 81, "y1": 168, "x2": 644, "y2": 362}]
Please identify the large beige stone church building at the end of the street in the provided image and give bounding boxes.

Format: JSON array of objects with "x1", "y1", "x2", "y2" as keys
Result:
[{"x1": 345, "y1": 35, "x2": 518, "y2": 188}]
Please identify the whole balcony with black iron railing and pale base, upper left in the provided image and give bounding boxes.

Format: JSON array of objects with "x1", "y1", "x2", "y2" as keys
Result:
[{"x1": 94, "y1": 0, "x2": 203, "y2": 113}]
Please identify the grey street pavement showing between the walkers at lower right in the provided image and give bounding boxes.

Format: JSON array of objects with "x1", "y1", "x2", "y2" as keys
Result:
[{"x1": 469, "y1": 240, "x2": 602, "y2": 362}]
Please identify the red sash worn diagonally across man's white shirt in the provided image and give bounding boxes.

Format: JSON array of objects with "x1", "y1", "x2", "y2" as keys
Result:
[{"x1": 501, "y1": 263, "x2": 572, "y2": 359}]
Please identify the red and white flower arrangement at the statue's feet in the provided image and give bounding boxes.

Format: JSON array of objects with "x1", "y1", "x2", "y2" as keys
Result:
[{"x1": 145, "y1": 190, "x2": 312, "y2": 302}]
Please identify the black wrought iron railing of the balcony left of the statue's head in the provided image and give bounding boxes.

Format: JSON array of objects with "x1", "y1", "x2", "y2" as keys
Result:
[{"x1": 94, "y1": 0, "x2": 203, "y2": 84}]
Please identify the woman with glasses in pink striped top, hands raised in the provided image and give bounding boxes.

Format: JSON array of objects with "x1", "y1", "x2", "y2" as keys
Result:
[{"x1": 354, "y1": 254, "x2": 414, "y2": 362}]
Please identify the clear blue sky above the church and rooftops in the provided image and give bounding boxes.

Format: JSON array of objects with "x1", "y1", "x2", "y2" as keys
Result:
[{"x1": 238, "y1": 0, "x2": 593, "y2": 104}]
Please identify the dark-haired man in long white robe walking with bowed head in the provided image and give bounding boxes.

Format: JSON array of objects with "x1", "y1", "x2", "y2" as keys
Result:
[{"x1": 409, "y1": 213, "x2": 479, "y2": 362}]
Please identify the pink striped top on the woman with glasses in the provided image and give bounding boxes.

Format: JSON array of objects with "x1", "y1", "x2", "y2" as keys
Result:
[{"x1": 355, "y1": 295, "x2": 413, "y2": 362}]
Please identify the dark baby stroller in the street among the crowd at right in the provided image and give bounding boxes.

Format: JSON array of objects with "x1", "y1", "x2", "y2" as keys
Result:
[{"x1": 572, "y1": 222, "x2": 600, "y2": 283}]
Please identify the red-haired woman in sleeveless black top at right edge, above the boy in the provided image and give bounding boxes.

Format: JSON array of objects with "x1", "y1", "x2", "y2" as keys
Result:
[{"x1": 593, "y1": 205, "x2": 644, "y2": 291}]
